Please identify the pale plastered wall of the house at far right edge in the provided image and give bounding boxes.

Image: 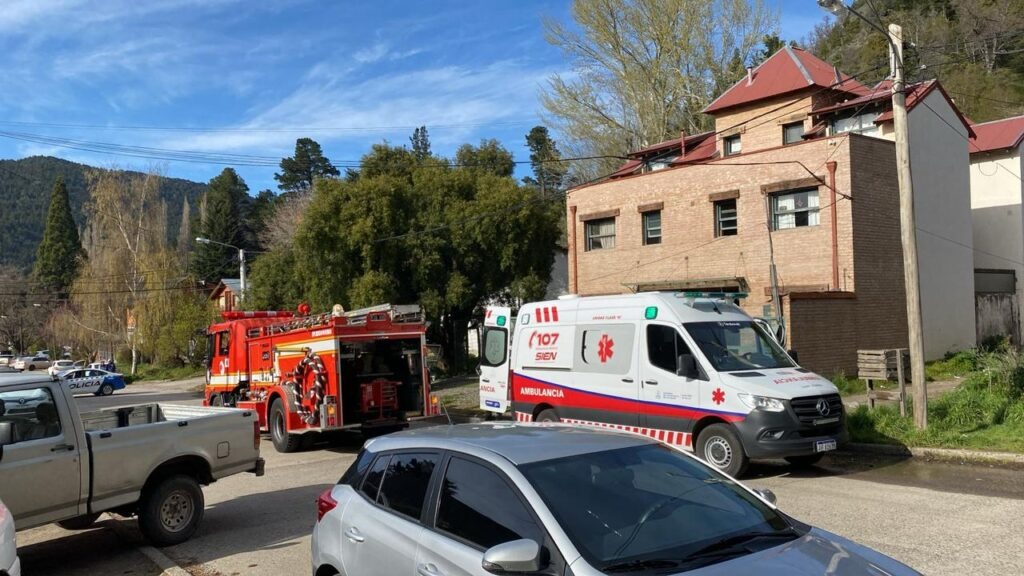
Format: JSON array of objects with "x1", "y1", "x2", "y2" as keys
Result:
[{"x1": 971, "y1": 148, "x2": 1024, "y2": 333}]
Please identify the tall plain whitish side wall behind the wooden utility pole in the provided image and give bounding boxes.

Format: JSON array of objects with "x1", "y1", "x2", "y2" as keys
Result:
[{"x1": 909, "y1": 90, "x2": 976, "y2": 360}]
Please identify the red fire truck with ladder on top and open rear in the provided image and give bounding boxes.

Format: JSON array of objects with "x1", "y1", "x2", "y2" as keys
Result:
[{"x1": 204, "y1": 304, "x2": 437, "y2": 452}]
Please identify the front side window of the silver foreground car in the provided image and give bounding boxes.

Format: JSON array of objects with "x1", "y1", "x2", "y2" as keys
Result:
[{"x1": 435, "y1": 458, "x2": 545, "y2": 549}]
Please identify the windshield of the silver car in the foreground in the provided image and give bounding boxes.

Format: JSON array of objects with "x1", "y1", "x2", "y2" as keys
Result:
[{"x1": 519, "y1": 444, "x2": 799, "y2": 574}]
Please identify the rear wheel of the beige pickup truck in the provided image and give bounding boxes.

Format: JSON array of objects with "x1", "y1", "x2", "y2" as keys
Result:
[{"x1": 138, "y1": 476, "x2": 206, "y2": 546}]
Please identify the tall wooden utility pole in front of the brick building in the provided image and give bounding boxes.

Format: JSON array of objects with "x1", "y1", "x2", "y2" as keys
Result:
[{"x1": 889, "y1": 24, "x2": 928, "y2": 429}]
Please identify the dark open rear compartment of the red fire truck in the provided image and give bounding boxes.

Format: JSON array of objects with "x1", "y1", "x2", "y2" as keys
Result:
[{"x1": 338, "y1": 338, "x2": 424, "y2": 424}]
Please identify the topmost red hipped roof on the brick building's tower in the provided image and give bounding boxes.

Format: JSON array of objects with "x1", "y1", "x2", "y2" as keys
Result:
[{"x1": 703, "y1": 46, "x2": 868, "y2": 114}]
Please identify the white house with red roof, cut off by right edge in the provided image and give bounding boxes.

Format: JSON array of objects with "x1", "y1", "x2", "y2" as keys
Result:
[{"x1": 971, "y1": 116, "x2": 1024, "y2": 344}]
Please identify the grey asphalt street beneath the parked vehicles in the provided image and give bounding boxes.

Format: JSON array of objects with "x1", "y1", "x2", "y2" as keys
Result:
[{"x1": 12, "y1": 377, "x2": 1024, "y2": 576}]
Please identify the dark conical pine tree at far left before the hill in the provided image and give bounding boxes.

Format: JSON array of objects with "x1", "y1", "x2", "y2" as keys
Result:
[{"x1": 33, "y1": 177, "x2": 83, "y2": 295}]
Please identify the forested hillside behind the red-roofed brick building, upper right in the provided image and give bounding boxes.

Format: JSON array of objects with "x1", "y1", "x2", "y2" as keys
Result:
[{"x1": 806, "y1": 0, "x2": 1024, "y2": 122}]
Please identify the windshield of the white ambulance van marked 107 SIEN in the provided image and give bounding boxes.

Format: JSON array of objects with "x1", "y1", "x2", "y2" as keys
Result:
[{"x1": 684, "y1": 322, "x2": 795, "y2": 372}]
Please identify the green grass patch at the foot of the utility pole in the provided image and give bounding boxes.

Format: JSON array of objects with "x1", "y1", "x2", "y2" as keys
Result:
[{"x1": 847, "y1": 347, "x2": 1024, "y2": 453}]
